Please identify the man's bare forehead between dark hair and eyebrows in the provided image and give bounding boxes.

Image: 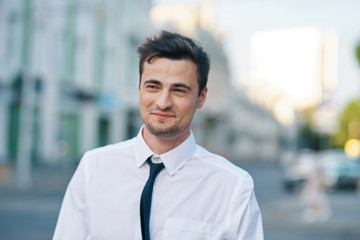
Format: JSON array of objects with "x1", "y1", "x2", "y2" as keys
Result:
[{"x1": 141, "y1": 58, "x2": 197, "y2": 83}]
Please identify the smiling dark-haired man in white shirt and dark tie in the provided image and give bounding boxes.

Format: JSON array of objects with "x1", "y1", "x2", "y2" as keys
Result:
[{"x1": 54, "y1": 31, "x2": 263, "y2": 240}]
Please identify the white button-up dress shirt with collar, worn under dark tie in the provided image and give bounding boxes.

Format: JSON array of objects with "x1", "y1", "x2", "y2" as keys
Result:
[{"x1": 53, "y1": 126, "x2": 263, "y2": 240}]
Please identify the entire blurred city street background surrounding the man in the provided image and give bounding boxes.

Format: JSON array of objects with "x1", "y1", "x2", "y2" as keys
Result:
[{"x1": 0, "y1": 0, "x2": 360, "y2": 240}]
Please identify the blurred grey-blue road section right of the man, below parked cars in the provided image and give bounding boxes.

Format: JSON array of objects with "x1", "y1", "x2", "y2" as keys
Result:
[{"x1": 242, "y1": 164, "x2": 360, "y2": 240}]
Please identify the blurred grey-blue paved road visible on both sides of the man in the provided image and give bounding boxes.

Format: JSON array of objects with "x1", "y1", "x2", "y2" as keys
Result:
[{"x1": 0, "y1": 164, "x2": 360, "y2": 240}]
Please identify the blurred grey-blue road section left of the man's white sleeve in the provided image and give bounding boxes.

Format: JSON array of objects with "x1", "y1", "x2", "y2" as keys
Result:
[{"x1": 0, "y1": 169, "x2": 74, "y2": 240}]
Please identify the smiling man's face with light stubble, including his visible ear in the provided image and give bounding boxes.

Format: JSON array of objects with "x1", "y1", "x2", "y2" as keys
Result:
[{"x1": 139, "y1": 58, "x2": 207, "y2": 137}]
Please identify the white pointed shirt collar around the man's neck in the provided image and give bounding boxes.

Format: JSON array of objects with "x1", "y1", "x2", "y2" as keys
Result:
[{"x1": 135, "y1": 126, "x2": 196, "y2": 175}]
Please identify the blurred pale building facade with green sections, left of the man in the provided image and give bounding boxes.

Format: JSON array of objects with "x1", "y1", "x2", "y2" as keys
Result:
[{"x1": 0, "y1": 0, "x2": 151, "y2": 172}]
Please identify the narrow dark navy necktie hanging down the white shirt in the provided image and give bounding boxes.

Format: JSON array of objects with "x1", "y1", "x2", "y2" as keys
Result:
[{"x1": 140, "y1": 156, "x2": 164, "y2": 240}]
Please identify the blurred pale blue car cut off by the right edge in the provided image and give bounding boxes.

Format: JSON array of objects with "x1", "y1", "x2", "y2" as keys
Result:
[{"x1": 320, "y1": 150, "x2": 360, "y2": 191}]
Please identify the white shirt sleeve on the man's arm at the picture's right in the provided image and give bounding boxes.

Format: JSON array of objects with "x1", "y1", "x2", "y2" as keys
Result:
[{"x1": 227, "y1": 174, "x2": 264, "y2": 240}]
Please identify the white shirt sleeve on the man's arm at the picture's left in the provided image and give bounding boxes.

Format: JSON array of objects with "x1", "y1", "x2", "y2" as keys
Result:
[{"x1": 53, "y1": 155, "x2": 88, "y2": 240}]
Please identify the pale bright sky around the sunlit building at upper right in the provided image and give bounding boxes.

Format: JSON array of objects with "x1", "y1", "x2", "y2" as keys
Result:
[{"x1": 153, "y1": 0, "x2": 360, "y2": 107}]
